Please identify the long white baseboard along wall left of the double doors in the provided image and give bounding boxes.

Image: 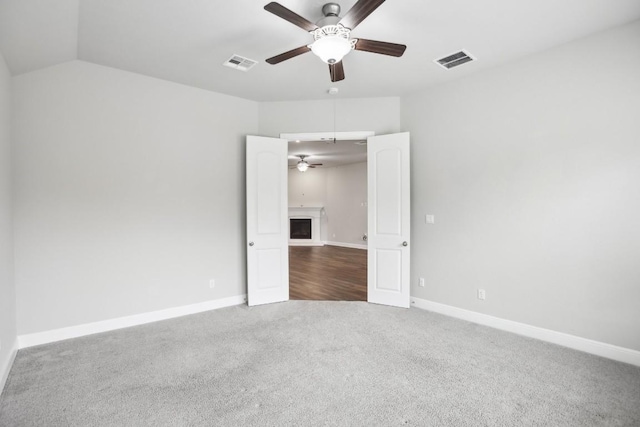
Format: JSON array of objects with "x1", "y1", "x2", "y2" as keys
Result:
[{"x1": 18, "y1": 294, "x2": 247, "y2": 348}]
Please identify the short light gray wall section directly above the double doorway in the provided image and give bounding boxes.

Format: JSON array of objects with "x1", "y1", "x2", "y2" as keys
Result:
[{"x1": 260, "y1": 95, "x2": 400, "y2": 137}]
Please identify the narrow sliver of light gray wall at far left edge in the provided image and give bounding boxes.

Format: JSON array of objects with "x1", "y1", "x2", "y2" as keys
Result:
[{"x1": 0, "y1": 54, "x2": 17, "y2": 393}]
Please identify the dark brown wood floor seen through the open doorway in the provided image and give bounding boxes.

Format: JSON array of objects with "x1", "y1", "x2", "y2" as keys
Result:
[{"x1": 289, "y1": 246, "x2": 367, "y2": 301}]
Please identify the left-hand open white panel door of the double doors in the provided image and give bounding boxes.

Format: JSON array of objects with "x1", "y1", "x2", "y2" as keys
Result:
[{"x1": 247, "y1": 136, "x2": 289, "y2": 306}]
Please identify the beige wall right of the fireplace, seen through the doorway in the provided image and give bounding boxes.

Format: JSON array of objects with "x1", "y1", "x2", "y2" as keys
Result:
[{"x1": 326, "y1": 162, "x2": 367, "y2": 245}]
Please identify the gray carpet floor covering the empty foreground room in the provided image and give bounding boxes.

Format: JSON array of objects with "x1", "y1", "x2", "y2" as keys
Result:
[{"x1": 0, "y1": 301, "x2": 640, "y2": 426}]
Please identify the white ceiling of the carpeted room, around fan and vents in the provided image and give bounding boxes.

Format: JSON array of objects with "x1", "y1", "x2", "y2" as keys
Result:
[{"x1": 0, "y1": 0, "x2": 640, "y2": 101}]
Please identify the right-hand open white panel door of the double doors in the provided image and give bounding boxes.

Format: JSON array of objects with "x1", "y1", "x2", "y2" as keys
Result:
[{"x1": 367, "y1": 132, "x2": 411, "y2": 308}]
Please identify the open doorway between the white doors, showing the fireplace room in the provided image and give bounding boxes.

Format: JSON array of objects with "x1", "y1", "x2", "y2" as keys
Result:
[{"x1": 281, "y1": 132, "x2": 372, "y2": 301}]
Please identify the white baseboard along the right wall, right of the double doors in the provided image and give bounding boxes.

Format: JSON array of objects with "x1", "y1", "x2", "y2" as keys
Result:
[{"x1": 411, "y1": 297, "x2": 640, "y2": 366}]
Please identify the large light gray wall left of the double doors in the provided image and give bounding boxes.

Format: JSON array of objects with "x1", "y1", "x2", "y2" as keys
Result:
[{"x1": 13, "y1": 61, "x2": 258, "y2": 334}]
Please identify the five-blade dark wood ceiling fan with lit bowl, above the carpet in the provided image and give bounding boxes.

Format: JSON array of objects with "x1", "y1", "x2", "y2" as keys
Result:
[{"x1": 264, "y1": 0, "x2": 407, "y2": 82}]
